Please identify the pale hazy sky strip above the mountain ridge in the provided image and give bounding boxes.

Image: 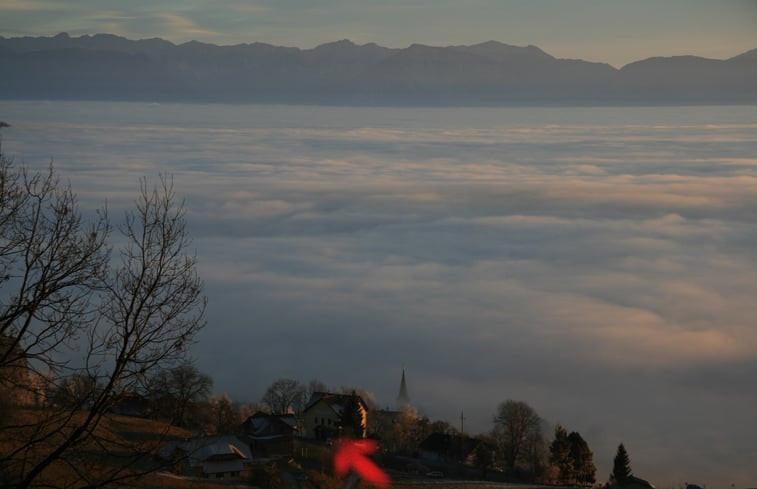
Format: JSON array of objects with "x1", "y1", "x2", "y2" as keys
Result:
[{"x1": 0, "y1": 0, "x2": 757, "y2": 67}]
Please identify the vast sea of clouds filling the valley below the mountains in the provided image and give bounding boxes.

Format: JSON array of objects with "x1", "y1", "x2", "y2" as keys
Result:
[{"x1": 0, "y1": 102, "x2": 757, "y2": 487}]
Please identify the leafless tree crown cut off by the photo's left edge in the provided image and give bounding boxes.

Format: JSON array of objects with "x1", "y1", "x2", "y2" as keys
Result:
[{"x1": 0, "y1": 152, "x2": 110, "y2": 400}]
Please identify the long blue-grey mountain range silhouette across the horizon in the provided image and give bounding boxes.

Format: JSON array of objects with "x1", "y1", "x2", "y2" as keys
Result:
[{"x1": 0, "y1": 33, "x2": 757, "y2": 106}]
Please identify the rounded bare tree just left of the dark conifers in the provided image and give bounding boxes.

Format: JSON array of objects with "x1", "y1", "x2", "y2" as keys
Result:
[{"x1": 492, "y1": 400, "x2": 543, "y2": 473}]
